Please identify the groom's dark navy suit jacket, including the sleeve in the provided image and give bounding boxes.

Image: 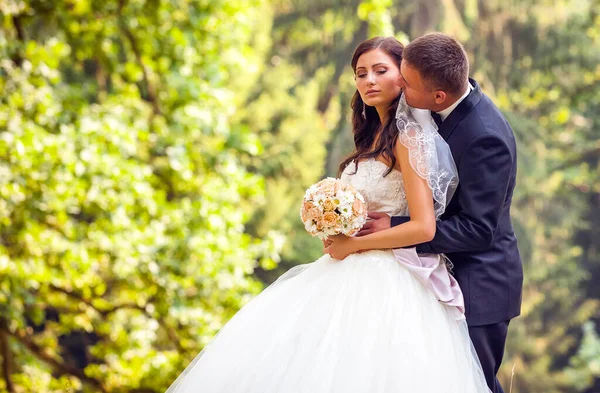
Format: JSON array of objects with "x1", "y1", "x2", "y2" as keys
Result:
[{"x1": 392, "y1": 79, "x2": 523, "y2": 326}]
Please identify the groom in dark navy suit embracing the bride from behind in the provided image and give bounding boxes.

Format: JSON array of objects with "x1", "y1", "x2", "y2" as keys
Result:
[{"x1": 359, "y1": 33, "x2": 523, "y2": 393}]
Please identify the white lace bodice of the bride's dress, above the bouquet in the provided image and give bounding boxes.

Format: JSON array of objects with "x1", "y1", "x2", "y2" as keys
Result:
[{"x1": 341, "y1": 159, "x2": 408, "y2": 216}]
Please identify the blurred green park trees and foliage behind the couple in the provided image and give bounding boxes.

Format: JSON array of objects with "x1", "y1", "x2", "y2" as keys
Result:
[{"x1": 0, "y1": 0, "x2": 600, "y2": 393}]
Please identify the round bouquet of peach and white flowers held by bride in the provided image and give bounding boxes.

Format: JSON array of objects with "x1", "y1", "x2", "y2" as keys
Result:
[{"x1": 300, "y1": 177, "x2": 367, "y2": 239}]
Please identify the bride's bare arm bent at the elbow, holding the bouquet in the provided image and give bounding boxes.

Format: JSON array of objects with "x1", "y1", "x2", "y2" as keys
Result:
[{"x1": 324, "y1": 141, "x2": 436, "y2": 259}]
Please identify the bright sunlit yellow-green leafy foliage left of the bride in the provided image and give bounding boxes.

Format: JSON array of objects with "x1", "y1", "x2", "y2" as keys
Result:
[{"x1": 0, "y1": 0, "x2": 280, "y2": 393}]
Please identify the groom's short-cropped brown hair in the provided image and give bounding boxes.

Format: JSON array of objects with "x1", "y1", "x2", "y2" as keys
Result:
[{"x1": 403, "y1": 33, "x2": 469, "y2": 94}]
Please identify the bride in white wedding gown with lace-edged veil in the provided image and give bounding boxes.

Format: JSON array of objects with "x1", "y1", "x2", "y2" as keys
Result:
[{"x1": 167, "y1": 37, "x2": 489, "y2": 393}]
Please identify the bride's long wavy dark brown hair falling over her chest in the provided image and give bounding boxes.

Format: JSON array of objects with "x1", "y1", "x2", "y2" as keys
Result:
[{"x1": 338, "y1": 37, "x2": 404, "y2": 177}]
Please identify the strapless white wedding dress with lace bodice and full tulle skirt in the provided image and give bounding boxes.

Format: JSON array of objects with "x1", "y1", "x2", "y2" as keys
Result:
[{"x1": 168, "y1": 160, "x2": 489, "y2": 393}]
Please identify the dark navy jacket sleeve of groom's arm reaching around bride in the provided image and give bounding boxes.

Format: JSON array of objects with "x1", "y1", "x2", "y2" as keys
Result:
[{"x1": 391, "y1": 135, "x2": 513, "y2": 253}]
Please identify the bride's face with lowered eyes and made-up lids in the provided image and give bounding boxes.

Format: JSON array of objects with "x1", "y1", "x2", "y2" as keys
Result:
[{"x1": 354, "y1": 49, "x2": 400, "y2": 109}]
